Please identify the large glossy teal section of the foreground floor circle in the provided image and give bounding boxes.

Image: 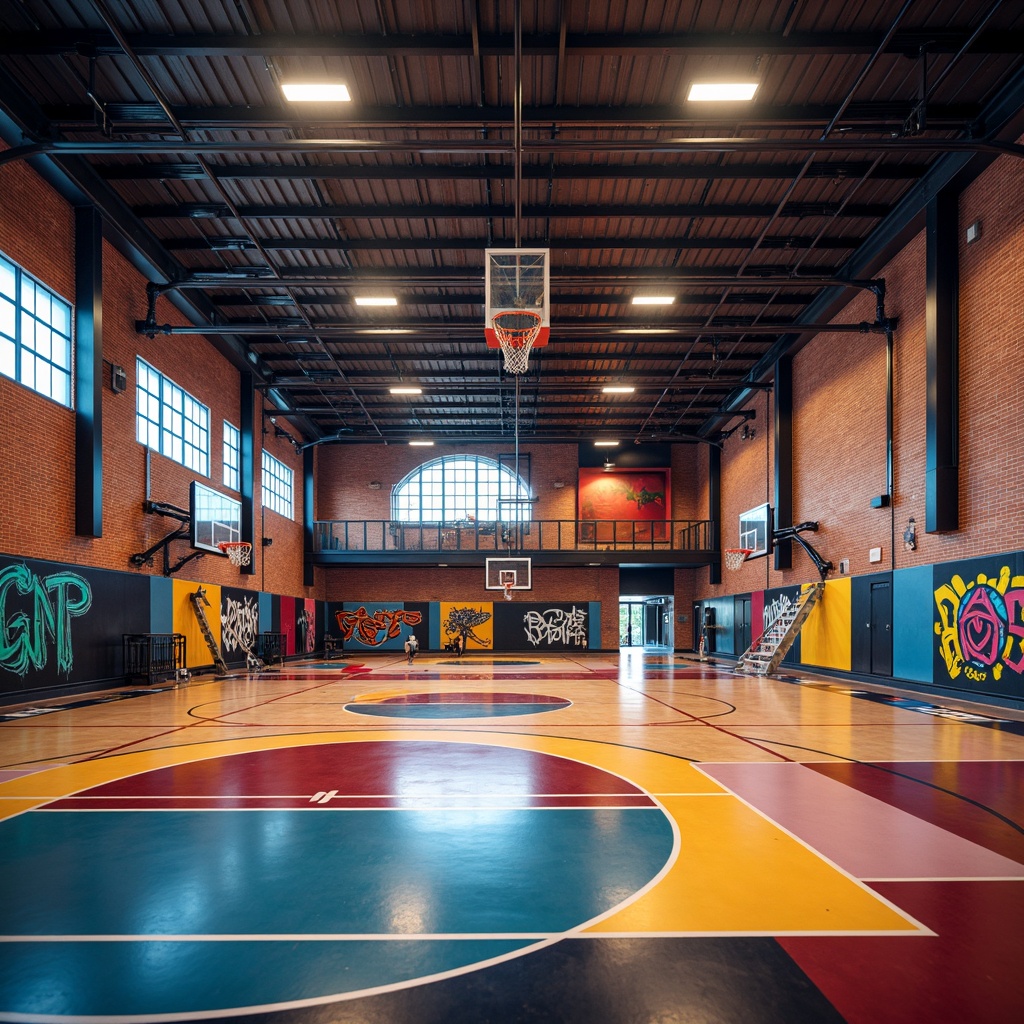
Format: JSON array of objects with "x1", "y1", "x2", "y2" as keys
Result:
[{"x1": 0, "y1": 802, "x2": 673, "y2": 1021}]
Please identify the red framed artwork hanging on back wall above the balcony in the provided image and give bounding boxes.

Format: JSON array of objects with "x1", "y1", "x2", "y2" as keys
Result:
[{"x1": 579, "y1": 468, "x2": 672, "y2": 544}]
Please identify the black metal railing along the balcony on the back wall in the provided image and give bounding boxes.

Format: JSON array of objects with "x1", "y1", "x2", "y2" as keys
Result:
[{"x1": 313, "y1": 519, "x2": 715, "y2": 554}]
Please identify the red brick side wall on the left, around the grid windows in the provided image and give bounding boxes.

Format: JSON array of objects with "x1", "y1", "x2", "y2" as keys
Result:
[{"x1": 0, "y1": 144, "x2": 324, "y2": 597}]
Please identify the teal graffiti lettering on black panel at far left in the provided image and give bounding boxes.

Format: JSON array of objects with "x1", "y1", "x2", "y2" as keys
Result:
[{"x1": 0, "y1": 564, "x2": 92, "y2": 676}]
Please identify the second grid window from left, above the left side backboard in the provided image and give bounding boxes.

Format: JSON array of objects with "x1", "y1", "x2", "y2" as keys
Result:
[{"x1": 135, "y1": 359, "x2": 210, "y2": 476}]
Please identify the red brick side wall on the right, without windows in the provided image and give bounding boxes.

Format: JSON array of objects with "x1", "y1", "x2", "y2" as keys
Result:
[{"x1": 688, "y1": 145, "x2": 1024, "y2": 606}]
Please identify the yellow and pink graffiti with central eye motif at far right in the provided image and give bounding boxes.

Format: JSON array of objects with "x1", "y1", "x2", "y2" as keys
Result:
[{"x1": 935, "y1": 565, "x2": 1024, "y2": 682}]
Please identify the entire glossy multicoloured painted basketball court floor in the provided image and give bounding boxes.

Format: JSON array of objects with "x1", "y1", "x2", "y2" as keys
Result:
[{"x1": 0, "y1": 650, "x2": 1024, "y2": 1024}]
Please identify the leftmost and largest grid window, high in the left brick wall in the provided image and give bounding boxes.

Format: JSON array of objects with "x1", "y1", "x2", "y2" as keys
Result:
[{"x1": 0, "y1": 249, "x2": 74, "y2": 409}]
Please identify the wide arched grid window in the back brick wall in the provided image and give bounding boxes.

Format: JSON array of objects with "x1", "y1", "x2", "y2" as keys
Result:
[{"x1": 391, "y1": 455, "x2": 534, "y2": 522}]
